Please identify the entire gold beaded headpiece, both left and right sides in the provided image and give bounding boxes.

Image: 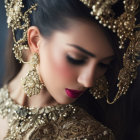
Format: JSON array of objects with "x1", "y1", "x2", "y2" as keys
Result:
[{"x1": 5, "y1": 0, "x2": 140, "y2": 103}]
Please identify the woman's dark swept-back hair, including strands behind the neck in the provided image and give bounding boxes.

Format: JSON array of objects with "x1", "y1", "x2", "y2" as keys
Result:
[{"x1": 5, "y1": 0, "x2": 120, "y2": 83}]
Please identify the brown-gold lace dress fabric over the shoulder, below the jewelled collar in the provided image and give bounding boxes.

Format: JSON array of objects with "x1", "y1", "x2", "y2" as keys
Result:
[{"x1": 29, "y1": 107, "x2": 114, "y2": 140}]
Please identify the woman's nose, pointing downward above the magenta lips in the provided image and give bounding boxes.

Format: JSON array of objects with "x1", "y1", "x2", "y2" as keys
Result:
[{"x1": 77, "y1": 64, "x2": 97, "y2": 88}]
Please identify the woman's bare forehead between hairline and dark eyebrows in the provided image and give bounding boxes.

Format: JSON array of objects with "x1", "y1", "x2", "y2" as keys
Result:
[{"x1": 42, "y1": 20, "x2": 114, "y2": 57}]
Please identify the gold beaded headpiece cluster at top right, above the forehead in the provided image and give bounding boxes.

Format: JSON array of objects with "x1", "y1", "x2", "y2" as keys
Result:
[{"x1": 80, "y1": 0, "x2": 140, "y2": 49}]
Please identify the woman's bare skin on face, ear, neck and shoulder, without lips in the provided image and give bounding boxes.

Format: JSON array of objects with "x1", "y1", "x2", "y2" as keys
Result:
[{"x1": 0, "y1": 20, "x2": 114, "y2": 139}]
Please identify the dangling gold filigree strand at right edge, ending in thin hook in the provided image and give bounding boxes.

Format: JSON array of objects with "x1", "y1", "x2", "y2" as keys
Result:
[{"x1": 107, "y1": 31, "x2": 140, "y2": 104}]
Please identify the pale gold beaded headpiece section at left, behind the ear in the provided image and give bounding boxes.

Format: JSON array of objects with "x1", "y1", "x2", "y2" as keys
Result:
[{"x1": 5, "y1": 0, "x2": 37, "y2": 62}]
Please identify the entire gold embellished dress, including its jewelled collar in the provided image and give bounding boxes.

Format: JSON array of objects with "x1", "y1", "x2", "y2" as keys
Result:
[{"x1": 0, "y1": 86, "x2": 114, "y2": 140}]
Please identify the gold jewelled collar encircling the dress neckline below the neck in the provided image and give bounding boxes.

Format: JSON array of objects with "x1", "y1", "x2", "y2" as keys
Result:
[{"x1": 0, "y1": 85, "x2": 76, "y2": 140}]
